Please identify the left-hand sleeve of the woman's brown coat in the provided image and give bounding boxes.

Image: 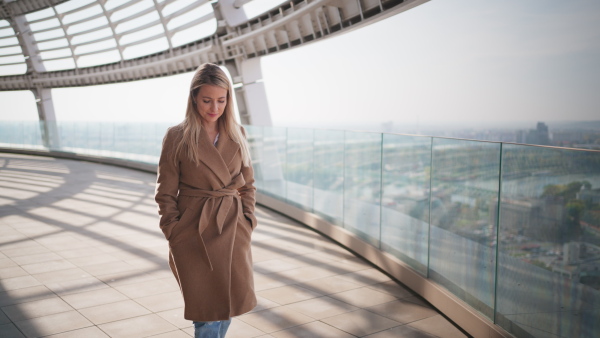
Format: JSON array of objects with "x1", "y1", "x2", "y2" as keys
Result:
[{"x1": 154, "y1": 128, "x2": 180, "y2": 239}]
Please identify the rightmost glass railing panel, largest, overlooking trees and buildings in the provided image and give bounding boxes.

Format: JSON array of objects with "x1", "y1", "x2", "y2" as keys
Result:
[{"x1": 496, "y1": 145, "x2": 600, "y2": 337}]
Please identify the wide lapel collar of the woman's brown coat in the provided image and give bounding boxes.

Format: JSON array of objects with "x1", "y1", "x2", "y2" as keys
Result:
[{"x1": 198, "y1": 124, "x2": 239, "y2": 188}]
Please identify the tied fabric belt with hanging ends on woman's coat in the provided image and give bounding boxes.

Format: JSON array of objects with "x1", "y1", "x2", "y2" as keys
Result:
[{"x1": 179, "y1": 173, "x2": 246, "y2": 271}]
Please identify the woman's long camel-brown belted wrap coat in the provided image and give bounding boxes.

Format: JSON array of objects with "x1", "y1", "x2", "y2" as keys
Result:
[{"x1": 155, "y1": 126, "x2": 256, "y2": 321}]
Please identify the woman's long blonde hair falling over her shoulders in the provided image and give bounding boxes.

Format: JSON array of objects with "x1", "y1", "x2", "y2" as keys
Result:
[{"x1": 175, "y1": 63, "x2": 250, "y2": 167}]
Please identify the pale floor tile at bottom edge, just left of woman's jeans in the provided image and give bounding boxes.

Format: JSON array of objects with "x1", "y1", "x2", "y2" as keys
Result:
[{"x1": 98, "y1": 314, "x2": 177, "y2": 338}]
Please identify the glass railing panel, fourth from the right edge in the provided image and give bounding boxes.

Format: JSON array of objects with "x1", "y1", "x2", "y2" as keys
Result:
[{"x1": 344, "y1": 131, "x2": 381, "y2": 247}]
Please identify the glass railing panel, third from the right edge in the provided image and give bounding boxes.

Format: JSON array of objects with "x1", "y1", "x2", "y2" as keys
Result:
[{"x1": 381, "y1": 134, "x2": 431, "y2": 275}]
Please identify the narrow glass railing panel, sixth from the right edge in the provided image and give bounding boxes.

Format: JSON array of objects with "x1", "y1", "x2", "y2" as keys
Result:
[{"x1": 285, "y1": 128, "x2": 313, "y2": 212}]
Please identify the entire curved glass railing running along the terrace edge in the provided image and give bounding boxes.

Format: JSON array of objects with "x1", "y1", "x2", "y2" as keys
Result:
[{"x1": 0, "y1": 123, "x2": 600, "y2": 337}]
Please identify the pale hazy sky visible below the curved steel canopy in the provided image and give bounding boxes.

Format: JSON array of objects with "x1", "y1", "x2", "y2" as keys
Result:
[{"x1": 0, "y1": 0, "x2": 600, "y2": 132}]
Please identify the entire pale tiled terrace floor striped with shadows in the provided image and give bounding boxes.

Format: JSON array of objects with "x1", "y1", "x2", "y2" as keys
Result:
[{"x1": 0, "y1": 154, "x2": 464, "y2": 338}]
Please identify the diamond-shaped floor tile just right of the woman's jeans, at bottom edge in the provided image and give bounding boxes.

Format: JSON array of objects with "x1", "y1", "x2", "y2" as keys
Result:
[{"x1": 239, "y1": 307, "x2": 314, "y2": 333}]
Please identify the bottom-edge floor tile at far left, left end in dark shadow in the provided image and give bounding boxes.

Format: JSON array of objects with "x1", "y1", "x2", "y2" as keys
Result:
[{"x1": 15, "y1": 311, "x2": 93, "y2": 337}]
